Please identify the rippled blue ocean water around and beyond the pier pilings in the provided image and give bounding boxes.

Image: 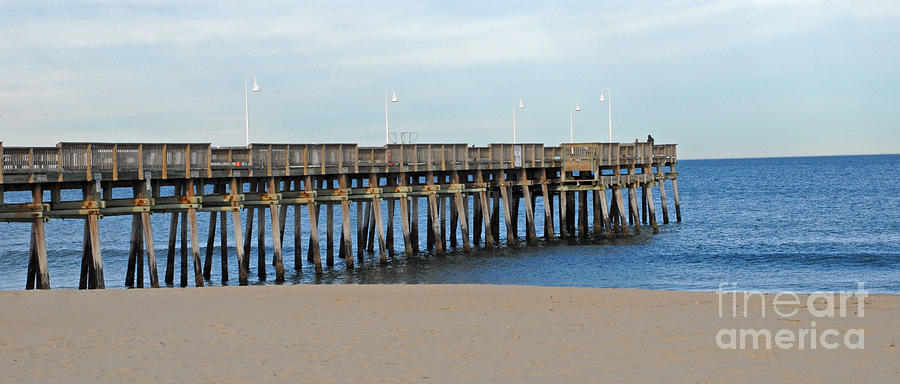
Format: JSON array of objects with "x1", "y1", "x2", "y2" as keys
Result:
[{"x1": 0, "y1": 155, "x2": 900, "y2": 293}]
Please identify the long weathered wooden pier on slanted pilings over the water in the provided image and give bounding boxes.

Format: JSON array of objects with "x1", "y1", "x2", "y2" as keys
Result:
[{"x1": 0, "y1": 142, "x2": 681, "y2": 289}]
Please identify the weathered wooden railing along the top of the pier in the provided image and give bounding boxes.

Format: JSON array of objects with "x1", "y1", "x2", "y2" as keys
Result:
[{"x1": 0, "y1": 142, "x2": 677, "y2": 183}]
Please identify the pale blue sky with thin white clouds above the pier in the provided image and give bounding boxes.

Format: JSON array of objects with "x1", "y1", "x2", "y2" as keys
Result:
[{"x1": 0, "y1": 0, "x2": 900, "y2": 158}]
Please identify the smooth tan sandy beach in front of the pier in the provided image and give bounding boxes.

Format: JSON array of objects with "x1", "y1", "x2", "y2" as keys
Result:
[{"x1": 0, "y1": 285, "x2": 900, "y2": 383}]
